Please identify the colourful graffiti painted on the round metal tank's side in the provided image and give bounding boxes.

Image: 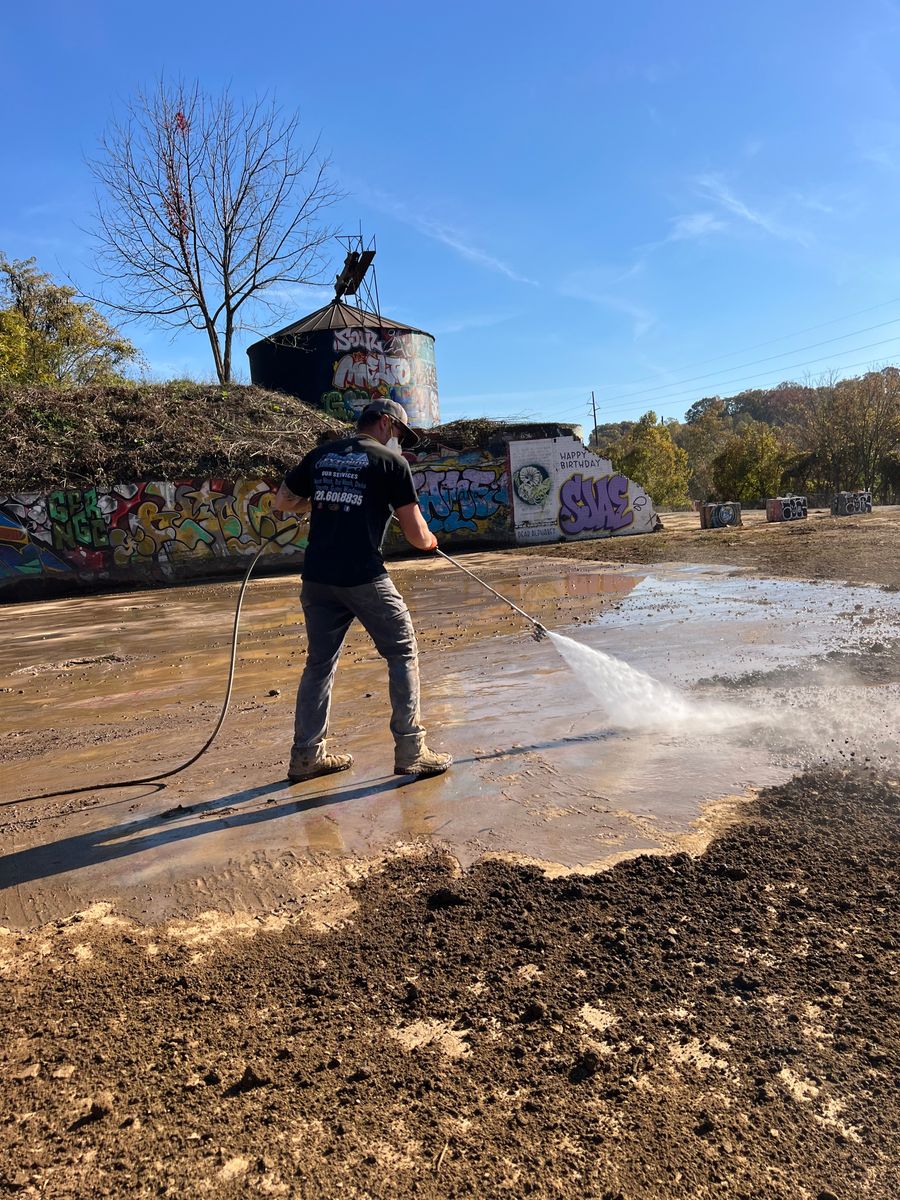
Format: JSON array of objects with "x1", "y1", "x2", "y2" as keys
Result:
[{"x1": 322, "y1": 329, "x2": 438, "y2": 425}]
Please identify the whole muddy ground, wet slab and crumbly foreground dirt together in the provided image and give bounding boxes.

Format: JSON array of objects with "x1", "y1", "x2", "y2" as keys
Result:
[{"x1": 0, "y1": 514, "x2": 900, "y2": 1200}]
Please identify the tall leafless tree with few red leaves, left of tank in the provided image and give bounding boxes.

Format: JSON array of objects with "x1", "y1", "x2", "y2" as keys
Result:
[{"x1": 90, "y1": 79, "x2": 340, "y2": 384}]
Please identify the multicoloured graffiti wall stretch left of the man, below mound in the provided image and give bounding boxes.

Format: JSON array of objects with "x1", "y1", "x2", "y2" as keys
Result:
[{"x1": 0, "y1": 479, "x2": 306, "y2": 594}]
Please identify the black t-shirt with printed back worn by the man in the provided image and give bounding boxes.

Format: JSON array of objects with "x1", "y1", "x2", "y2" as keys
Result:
[{"x1": 284, "y1": 437, "x2": 418, "y2": 588}]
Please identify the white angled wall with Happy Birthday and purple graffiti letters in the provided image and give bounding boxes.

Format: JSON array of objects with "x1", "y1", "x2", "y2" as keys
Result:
[{"x1": 509, "y1": 437, "x2": 656, "y2": 545}]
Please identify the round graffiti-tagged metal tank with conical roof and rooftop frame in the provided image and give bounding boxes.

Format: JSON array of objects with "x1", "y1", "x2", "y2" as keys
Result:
[{"x1": 247, "y1": 238, "x2": 439, "y2": 428}]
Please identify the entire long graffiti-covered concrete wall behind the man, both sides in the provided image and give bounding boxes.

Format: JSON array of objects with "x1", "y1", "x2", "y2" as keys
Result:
[{"x1": 0, "y1": 438, "x2": 655, "y2": 600}]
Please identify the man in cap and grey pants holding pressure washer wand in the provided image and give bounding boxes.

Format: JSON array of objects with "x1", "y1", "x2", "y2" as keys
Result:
[{"x1": 274, "y1": 400, "x2": 452, "y2": 782}]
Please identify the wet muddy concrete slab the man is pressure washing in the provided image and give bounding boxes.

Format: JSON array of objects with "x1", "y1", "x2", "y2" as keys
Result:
[{"x1": 0, "y1": 553, "x2": 900, "y2": 926}]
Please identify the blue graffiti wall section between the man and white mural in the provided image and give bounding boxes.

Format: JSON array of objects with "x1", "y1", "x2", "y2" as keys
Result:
[{"x1": 413, "y1": 458, "x2": 509, "y2": 536}]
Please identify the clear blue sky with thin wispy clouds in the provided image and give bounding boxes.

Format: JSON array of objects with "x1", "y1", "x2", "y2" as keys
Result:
[{"x1": 0, "y1": 0, "x2": 900, "y2": 425}]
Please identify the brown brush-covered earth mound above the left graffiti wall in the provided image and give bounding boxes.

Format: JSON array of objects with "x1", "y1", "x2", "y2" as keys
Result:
[{"x1": 0, "y1": 383, "x2": 346, "y2": 492}]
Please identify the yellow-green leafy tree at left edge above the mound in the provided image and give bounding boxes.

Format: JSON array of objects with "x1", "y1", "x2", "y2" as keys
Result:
[{"x1": 0, "y1": 253, "x2": 140, "y2": 385}]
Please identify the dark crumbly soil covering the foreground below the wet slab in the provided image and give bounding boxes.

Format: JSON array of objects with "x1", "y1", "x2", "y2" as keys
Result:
[{"x1": 0, "y1": 773, "x2": 900, "y2": 1200}]
